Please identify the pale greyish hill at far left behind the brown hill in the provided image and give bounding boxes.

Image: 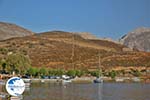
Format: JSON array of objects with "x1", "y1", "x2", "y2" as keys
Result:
[{"x1": 0, "y1": 22, "x2": 34, "y2": 40}]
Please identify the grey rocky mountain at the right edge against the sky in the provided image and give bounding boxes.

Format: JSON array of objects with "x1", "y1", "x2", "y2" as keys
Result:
[{"x1": 121, "y1": 28, "x2": 150, "y2": 52}]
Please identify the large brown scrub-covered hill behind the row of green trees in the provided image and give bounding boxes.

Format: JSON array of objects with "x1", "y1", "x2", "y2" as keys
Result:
[{"x1": 0, "y1": 31, "x2": 150, "y2": 70}]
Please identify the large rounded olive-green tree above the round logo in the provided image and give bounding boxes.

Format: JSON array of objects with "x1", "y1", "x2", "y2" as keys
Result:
[{"x1": 6, "y1": 53, "x2": 31, "y2": 74}]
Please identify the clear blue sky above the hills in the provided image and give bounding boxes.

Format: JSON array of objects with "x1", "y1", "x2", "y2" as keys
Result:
[{"x1": 0, "y1": 0, "x2": 150, "y2": 39}]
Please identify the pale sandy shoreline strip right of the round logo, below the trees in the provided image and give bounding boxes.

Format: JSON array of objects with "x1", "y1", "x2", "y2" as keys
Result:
[{"x1": 23, "y1": 77, "x2": 150, "y2": 83}]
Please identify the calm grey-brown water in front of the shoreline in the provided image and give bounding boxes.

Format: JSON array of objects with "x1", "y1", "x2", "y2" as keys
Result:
[{"x1": 0, "y1": 83, "x2": 150, "y2": 100}]
